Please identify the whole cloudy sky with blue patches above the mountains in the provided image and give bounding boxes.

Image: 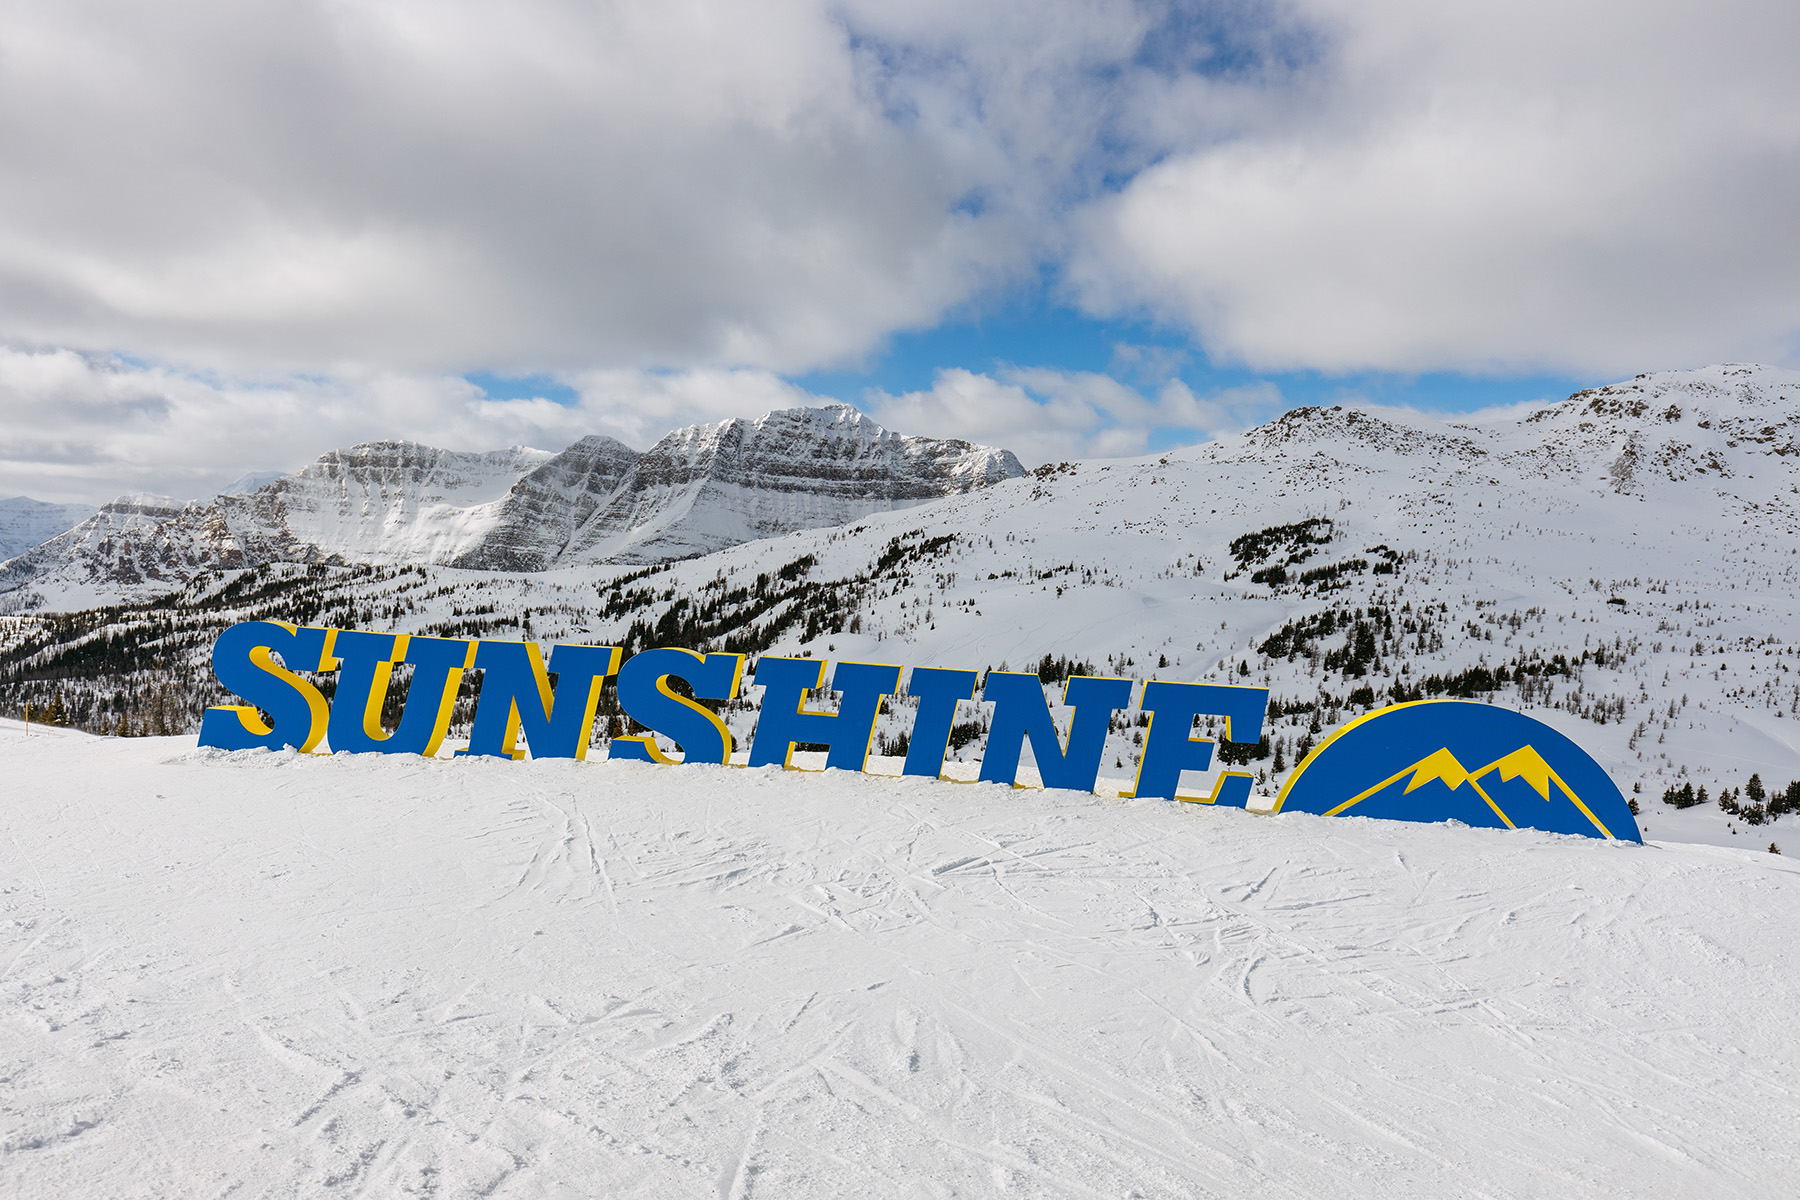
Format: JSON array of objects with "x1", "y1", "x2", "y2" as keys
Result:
[{"x1": 0, "y1": 0, "x2": 1800, "y2": 502}]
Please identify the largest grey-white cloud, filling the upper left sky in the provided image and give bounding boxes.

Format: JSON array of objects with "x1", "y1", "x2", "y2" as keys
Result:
[{"x1": 0, "y1": 0, "x2": 1202, "y2": 372}]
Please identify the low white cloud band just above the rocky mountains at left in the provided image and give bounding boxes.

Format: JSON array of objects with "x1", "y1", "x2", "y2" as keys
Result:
[{"x1": 0, "y1": 349, "x2": 821, "y2": 504}]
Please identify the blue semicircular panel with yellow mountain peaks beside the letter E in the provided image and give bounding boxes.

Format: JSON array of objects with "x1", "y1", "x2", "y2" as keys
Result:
[{"x1": 1274, "y1": 700, "x2": 1643, "y2": 842}]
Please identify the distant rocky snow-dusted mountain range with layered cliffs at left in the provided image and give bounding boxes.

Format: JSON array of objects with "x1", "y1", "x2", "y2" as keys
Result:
[{"x1": 0, "y1": 405, "x2": 1024, "y2": 610}]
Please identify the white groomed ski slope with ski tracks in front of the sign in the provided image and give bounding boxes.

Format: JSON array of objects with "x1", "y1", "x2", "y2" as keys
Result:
[{"x1": 0, "y1": 723, "x2": 1800, "y2": 1200}]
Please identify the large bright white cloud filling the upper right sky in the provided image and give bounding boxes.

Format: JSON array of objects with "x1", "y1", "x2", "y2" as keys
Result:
[{"x1": 1075, "y1": 0, "x2": 1800, "y2": 372}]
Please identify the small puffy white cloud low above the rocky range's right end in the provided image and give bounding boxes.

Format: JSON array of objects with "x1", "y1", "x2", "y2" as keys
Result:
[{"x1": 860, "y1": 367, "x2": 1282, "y2": 466}]
